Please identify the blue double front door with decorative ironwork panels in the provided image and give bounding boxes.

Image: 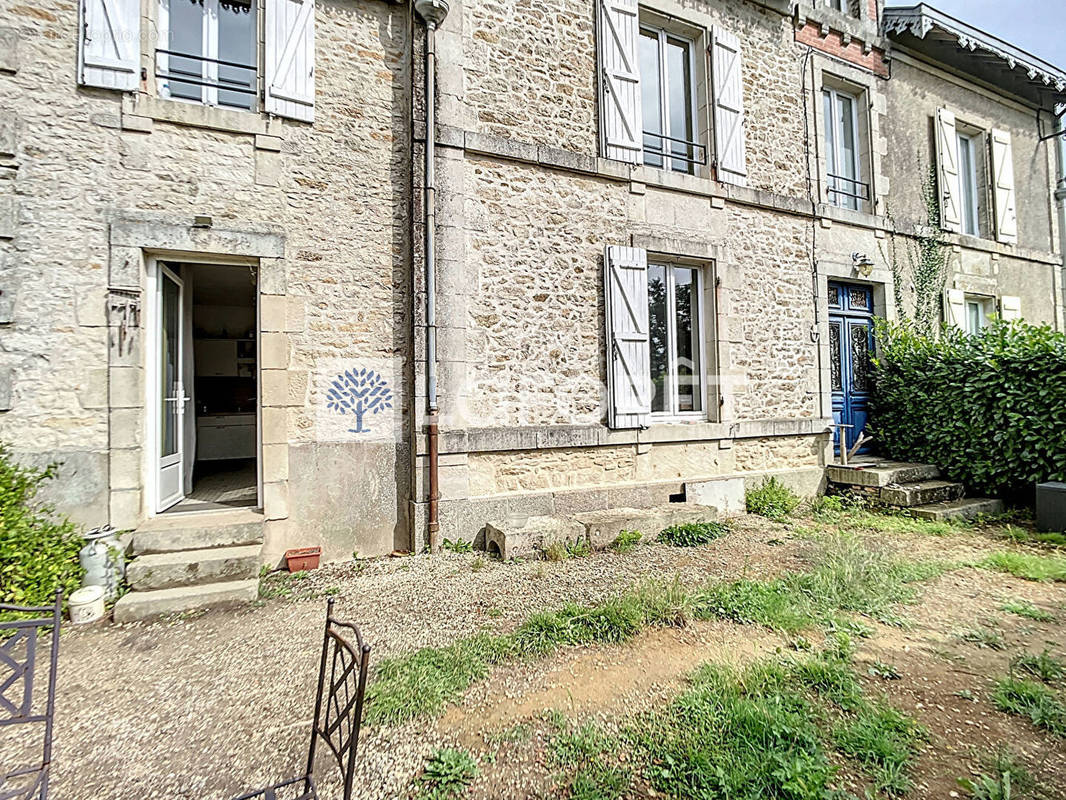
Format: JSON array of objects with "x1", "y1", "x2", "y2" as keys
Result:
[{"x1": 829, "y1": 283, "x2": 873, "y2": 453}]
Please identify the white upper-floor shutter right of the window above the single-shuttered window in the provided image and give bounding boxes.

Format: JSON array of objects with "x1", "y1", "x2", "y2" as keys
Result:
[{"x1": 711, "y1": 28, "x2": 747, "y2": 186}]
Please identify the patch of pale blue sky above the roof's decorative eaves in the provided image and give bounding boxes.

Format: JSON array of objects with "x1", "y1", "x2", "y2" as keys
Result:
[{"x1": 887, "y1": 0, "x2": 1066, "y2": 69}]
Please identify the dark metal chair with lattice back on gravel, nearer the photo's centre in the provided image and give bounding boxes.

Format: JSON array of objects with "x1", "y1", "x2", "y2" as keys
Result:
[{"x1": 229, "y1": 599, "x2": 370, "y2": 800}]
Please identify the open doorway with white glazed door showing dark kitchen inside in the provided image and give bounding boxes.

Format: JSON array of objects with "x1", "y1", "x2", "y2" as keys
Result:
[{"x1": 148, "y1": 259, "x2": 260, "y2": 513}]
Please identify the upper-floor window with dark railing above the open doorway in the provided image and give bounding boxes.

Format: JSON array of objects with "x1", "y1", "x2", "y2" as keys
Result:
[{"x1": 156, "y1": 0, "x2": 258, "y2": 110}]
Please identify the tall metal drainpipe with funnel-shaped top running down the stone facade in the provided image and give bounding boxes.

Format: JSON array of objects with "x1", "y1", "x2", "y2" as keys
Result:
[{"x1": 415, "y1": 0, "x2": 448, "y2": 553}]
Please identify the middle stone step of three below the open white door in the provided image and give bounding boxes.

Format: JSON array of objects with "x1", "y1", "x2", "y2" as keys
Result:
[{"x1": 126, "y1": 544, "x2": 260, "y2": 591}]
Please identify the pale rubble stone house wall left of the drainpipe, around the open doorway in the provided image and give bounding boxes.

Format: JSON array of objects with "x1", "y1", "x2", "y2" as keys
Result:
[{"x1": 0, "y1": 0, "x2": 410, "y2": 558}]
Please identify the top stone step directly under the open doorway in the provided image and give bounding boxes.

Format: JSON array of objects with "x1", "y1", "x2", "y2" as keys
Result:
[{"x1": 133, "y1": 510, "x2": 263, "y2": 556}]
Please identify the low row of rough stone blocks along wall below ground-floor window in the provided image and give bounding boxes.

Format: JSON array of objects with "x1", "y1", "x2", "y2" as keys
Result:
[{"x1": 485, "y1": 502, "x2": 717, "y2": 561}]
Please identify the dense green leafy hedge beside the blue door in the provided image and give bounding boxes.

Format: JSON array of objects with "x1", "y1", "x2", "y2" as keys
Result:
[{"x1": 871, "y1": 321, "x2": 1066, "y2": 497}]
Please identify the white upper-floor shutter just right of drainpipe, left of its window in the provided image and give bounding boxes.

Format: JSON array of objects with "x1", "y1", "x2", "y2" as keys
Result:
[{"x1": 598, "y1": 0, "x2": 644, "y2": 164}]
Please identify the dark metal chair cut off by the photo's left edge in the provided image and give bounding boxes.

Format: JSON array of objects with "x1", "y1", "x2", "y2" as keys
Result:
[{"x1": 0, "y1": 590, "x2": 63, "y2": 800}]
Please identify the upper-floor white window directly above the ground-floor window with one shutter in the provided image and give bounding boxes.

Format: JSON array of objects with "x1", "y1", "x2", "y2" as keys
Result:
[{"x1": 640, "y1": 26, "x2": 706, "y2": 173}]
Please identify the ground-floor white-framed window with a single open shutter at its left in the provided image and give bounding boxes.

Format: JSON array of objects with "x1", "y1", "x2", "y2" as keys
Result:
[{"x1": 648, "y1": 262, "x2": 706, "y2": 416}]
